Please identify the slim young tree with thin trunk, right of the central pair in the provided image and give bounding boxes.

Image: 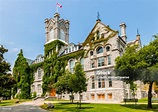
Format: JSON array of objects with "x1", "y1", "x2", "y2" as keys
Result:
[{"x1": 74, "y1": 62, "x2": 87, "y2": 108}]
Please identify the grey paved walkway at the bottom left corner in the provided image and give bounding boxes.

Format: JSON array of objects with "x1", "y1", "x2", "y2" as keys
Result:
[{"x1": 0, "y1": 99, "x2": 48, "y2": 112}]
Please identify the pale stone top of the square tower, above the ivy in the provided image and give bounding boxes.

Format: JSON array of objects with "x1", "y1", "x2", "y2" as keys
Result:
[{"x1": 45, "y1": 13, "x2": 69, "y2": 45}]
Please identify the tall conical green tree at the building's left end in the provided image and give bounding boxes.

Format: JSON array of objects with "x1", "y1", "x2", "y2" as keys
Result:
[{"x1": 13, "y1": 50, "x2": 33, "y2": 99}]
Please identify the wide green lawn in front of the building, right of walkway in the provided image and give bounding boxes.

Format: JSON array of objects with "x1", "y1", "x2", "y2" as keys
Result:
[{"x1": 41, "y1": 102, "x2": 158, "y2": 112}]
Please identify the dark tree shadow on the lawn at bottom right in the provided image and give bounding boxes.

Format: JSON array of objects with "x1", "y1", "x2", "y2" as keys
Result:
[{"x1": 121, "y1": 104, "x2": 158, "y2": 112}]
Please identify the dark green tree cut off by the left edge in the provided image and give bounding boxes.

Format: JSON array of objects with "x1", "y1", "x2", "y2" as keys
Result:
[{"x1": 0, "y1": 45, "x2": 16, "y2": 100}]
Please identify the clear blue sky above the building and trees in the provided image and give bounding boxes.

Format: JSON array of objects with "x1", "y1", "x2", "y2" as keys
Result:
[{"x1": 0, "y1": 0, "x2": 158, "y2": 66}]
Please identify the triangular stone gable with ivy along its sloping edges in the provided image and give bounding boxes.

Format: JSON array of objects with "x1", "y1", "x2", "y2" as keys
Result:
[{"x1": 82, "y1": 21, "x2": 118, "y2": 46}]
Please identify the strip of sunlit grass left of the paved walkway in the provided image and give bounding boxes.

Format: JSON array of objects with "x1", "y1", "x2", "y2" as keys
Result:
[{"x1": 0, "y1": 99, "x2": 32, "y2": 106}]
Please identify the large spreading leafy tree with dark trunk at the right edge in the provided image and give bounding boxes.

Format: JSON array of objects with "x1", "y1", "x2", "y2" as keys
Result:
[{"x1": 115, "y1": 35, "x2": 158, "y2": 108}]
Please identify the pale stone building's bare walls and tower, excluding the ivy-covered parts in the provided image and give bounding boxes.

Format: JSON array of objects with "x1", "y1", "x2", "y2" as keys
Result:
[{"x1": 31, "y1": 13, "x2": 146, "y2": 102}]
